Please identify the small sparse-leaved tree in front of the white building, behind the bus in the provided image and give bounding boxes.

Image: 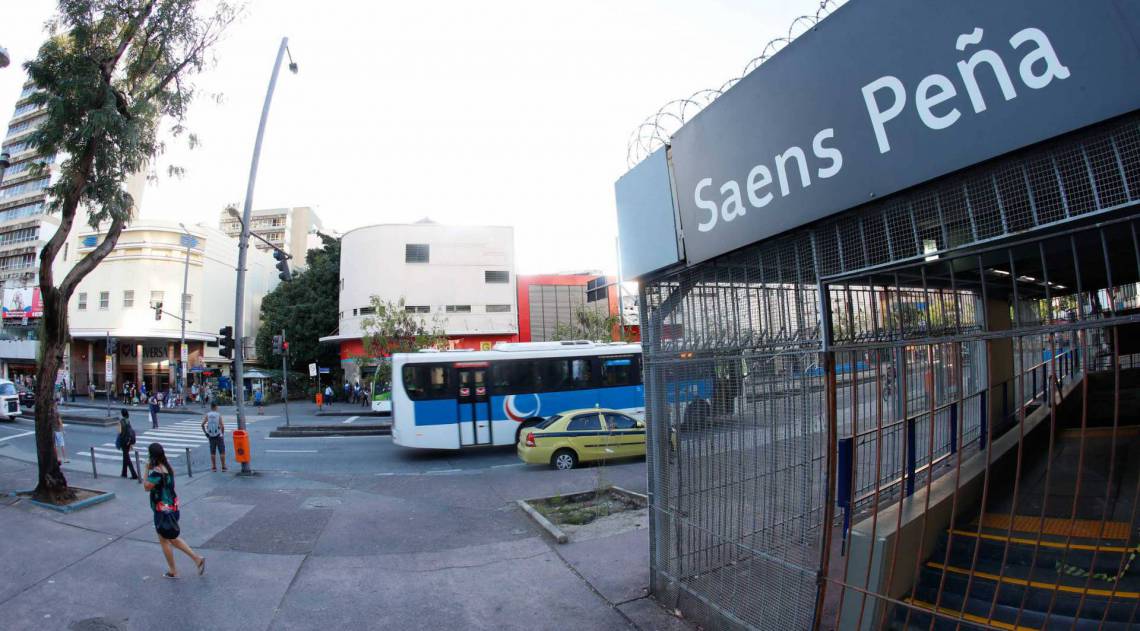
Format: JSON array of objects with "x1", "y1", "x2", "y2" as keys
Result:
[{"x1": 360, "y1": 296, "x2": 447, "y2": 386}]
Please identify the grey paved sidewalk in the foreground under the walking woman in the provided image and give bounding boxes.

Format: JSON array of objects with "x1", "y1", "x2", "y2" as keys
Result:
[{"x1": 0, "y1": 458, "x2": 691, "y2": 630}]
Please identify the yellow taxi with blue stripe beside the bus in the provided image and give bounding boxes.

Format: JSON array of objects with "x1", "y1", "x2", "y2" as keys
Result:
[{"x1": 518, "y1": 408, "x2": 645, "y2": 470}]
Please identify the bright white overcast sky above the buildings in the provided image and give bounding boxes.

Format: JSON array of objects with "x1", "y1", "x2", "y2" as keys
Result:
[{"x1": 0, "y1": 0, "x2": 817, "y2": 273}]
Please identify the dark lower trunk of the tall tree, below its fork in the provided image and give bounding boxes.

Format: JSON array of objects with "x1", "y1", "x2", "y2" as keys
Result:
[{"x1": 34, "y1": 286, "x2": 75, "y2": 503}]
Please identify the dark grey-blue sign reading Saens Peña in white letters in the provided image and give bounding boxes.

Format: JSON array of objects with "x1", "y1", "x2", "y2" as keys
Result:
[{"x1": 633, "y1": 0, "x2": 1140, "y2": 264}]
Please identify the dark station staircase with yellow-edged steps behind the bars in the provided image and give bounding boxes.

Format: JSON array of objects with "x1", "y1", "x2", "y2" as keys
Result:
[{"x1": 888, "y1": 513, "x2": 1140, "y2": 631}]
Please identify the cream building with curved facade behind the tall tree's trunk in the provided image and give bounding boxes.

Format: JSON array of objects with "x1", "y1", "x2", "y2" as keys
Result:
[{"x1": 63, "y1": 219, "x2": 278, "y2": 394}]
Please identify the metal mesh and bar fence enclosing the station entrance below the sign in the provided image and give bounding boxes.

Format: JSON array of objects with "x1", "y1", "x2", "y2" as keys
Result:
[{"x1": 641, "y1": 110, "x2": 1140, "y2": 629}]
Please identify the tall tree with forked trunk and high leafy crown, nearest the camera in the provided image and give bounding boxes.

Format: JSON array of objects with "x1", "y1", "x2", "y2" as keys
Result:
[{"x1": 24, "y1": 0, "x2": 236, "y2": 502}]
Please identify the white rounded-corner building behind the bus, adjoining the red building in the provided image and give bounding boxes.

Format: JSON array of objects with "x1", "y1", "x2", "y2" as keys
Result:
[{"x1": 321, "y1": 220, "x2": 519, "y2": 379}]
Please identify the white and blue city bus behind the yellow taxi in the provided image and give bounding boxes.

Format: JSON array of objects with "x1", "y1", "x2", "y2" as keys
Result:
[{"x1": 392, "y1": 342, "x2": 645, "y2": 449}]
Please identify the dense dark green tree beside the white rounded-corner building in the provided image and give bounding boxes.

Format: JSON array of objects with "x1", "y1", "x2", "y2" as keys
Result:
[{"x1": 254, "y1": 235, "x2": 341, "y2": 375}]
